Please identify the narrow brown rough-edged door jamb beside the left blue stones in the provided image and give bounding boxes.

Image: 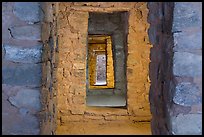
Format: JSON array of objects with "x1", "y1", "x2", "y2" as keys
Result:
[{"x1": 40, "y1": 2, "x2": 58, "y2": 135}]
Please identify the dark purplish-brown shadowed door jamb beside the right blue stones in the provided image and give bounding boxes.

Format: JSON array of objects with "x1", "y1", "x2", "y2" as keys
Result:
[{"x1": 148, "y1": 2, "x2": 174, "y2": 135}]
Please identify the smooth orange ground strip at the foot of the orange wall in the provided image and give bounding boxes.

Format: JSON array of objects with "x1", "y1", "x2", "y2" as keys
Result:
[{"x1": 57, "y1": 121, "x2": 151, "y2": 135}]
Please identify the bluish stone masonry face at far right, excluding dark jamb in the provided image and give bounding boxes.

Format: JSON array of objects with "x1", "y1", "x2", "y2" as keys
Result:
[{"x1": 171, "y1": 2, "x2": 202, "y2": 135}]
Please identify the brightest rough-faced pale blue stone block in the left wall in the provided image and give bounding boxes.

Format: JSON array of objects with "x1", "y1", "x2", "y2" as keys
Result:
[{"x1": 4, "y1": 44, "x2": 42, "y2": 63}]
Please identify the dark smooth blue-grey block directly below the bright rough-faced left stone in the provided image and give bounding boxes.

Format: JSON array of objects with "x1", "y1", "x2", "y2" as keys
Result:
[{"x1": 2, "y1": 63, "x2": 42, "y2": 87}]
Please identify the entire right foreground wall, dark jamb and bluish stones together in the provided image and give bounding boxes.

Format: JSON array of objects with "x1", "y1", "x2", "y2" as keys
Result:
[{"x1": 148, "y1": 2, "x2": 202, "y2": 135}]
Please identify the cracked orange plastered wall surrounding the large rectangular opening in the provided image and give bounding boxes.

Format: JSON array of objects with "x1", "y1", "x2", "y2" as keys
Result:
[{"x1": 56, "y1": 2, "x2": 151, "y2": 134}]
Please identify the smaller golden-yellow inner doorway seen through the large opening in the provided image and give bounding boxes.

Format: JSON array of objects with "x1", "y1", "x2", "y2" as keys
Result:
[{"x1": 88, "y1": 35, "x2": 114, "y2": 89}]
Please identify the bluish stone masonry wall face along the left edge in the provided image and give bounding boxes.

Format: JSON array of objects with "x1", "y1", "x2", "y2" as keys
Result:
[{"x1": 2, "y1": 2, "x2": 42, "y2": 135}]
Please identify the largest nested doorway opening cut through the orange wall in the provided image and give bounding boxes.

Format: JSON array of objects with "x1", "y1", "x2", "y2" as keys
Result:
[{"x1": 86, "y1": 12, "x2": 128, "y2": 108}]
